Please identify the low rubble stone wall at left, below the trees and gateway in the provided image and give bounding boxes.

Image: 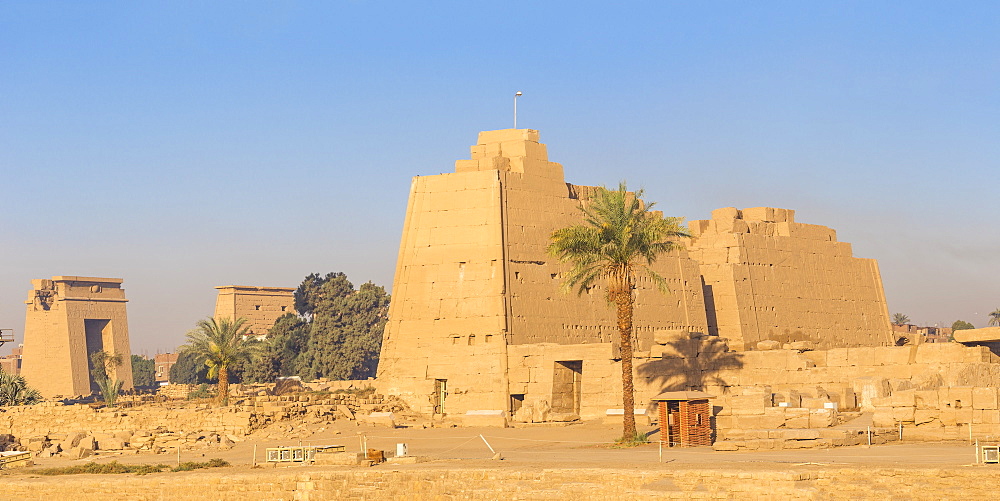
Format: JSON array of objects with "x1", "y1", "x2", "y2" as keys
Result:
[{"x1": 0, "y1": 393, "x2": 405, "y2": 458}]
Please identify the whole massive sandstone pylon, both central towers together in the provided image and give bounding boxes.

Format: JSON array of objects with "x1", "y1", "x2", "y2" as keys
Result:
[{"x1": 378, "y1": 129, "x2": 892, "y2": 418}]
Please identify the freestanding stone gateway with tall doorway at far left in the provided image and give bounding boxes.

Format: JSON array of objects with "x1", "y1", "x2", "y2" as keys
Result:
[{"x1": 21, "y1": 276, "x2": 132, "y2": 397}]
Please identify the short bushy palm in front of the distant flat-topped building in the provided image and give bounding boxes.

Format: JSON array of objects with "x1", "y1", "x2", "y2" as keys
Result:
[{"x1": 182, "y1": 318, "x2": 261, "y2": 405}]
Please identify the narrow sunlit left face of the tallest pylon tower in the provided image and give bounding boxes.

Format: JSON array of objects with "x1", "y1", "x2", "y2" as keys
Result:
[{"x1": 378, "y1": 152, "x2": 507, "y2": 413}]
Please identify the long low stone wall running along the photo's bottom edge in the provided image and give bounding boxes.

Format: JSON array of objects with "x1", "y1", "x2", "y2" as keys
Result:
[{"x1": 3, "y1": 467, "x2": 997, "y2": 501}]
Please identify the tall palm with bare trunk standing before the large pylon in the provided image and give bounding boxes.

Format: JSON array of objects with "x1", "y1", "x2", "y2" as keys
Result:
[{"x1": 548, "y1": 182, "x2": 688, "y2": 441}]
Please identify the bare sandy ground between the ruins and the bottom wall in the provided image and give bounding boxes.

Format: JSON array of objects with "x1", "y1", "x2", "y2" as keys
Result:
[{"x1": 8, "y1": 422, "x2": 988, "y2": 474}]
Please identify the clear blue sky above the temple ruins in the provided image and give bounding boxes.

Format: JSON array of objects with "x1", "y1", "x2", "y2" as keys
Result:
[{"x1": 0, "y1": 1, "x2": 1000, "y2": 354}]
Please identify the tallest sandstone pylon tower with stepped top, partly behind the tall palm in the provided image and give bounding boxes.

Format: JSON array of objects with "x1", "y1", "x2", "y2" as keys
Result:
[{"x1": 379, "y1": 129, "x2": 707, "y2": 413}]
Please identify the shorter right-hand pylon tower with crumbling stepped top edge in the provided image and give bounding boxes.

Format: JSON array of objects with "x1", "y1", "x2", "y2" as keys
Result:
[{"x1": 688, "y1": 207, "x2": 894, "y2": 350}]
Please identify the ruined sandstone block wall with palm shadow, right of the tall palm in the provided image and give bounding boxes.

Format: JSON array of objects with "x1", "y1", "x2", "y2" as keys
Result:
[{"x1": 636, "y1": 336, "x2": 1000, "y2": 450}]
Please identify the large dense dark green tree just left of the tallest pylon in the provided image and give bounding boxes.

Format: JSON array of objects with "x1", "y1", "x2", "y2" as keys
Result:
[{"x1": 289, "y1": 273, "x2": 389, "y2": 379}]
